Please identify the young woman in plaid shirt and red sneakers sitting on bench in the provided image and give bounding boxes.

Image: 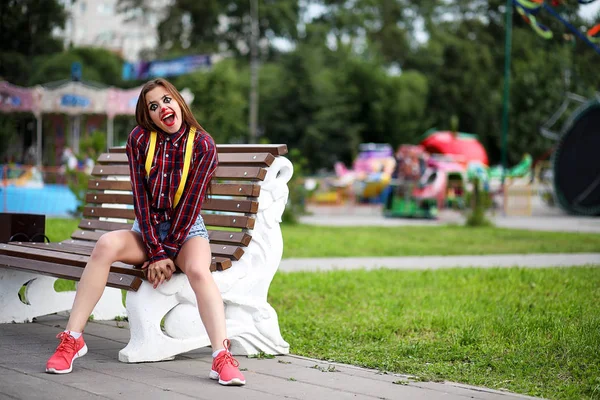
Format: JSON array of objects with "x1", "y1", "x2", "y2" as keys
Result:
[{"x1": 46, "y1": 79, "x2": 246, "y2": 385}]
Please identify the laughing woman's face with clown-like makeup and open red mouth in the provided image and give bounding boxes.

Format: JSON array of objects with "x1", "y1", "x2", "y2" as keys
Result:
[{"x1": 146, "y1": 86, "x2": 183, "y2": 133}]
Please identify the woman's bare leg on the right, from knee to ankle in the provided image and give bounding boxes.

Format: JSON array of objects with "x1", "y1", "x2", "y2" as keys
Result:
[{"x1": 175, "y1": 237, "x2": 227, "y2": 351}]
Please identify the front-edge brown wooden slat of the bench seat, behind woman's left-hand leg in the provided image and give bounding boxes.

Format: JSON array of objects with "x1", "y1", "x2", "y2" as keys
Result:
[{"x1": 0, "y1": 254, "x2": 142, "y2": 291}]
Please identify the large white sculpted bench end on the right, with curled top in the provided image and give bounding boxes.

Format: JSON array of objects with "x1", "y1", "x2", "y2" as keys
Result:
[{"x1": 119, "y1": 157, "x2": 293, "y2": 362}]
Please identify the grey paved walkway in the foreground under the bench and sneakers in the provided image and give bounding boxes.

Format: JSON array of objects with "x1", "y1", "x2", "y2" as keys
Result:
[{"x1": 0, "y1": 316, "x2": 531, "y2": 400}]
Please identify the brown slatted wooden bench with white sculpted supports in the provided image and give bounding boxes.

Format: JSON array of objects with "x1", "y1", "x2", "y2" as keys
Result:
[{"x1": 0, "y1": 145, "x2": 293, "y2": 362}]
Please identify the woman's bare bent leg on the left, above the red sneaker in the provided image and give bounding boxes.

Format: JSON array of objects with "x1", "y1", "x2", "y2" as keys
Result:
[{"x1": 67, "y1": 230, "x2": 146, "y2": 332}]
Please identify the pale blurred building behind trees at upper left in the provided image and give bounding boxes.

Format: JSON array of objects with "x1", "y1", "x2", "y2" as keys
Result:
[{"x1": 57, "y1": 0, "x2": 172, "y2": 62}]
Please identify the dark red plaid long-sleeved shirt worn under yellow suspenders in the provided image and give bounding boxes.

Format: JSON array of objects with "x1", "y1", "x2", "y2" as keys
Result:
[{"x1": 126, "y1": 123, "x2": 218, "y2": 262}]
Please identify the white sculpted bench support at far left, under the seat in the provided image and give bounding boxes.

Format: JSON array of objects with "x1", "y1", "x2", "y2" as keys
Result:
[{"x1": 0, "y1": 268, "x2": 127, "y2": 323}]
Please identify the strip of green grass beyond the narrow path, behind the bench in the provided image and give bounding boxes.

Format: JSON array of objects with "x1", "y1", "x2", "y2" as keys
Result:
[{"x1": 46, "y1": 219, "x2": 600, "y2": 258}]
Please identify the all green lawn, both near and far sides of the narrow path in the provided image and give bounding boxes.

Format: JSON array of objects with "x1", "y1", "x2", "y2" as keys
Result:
[{"x1": 46, "y1": 219, "x2": 600, "y2": 399}]
